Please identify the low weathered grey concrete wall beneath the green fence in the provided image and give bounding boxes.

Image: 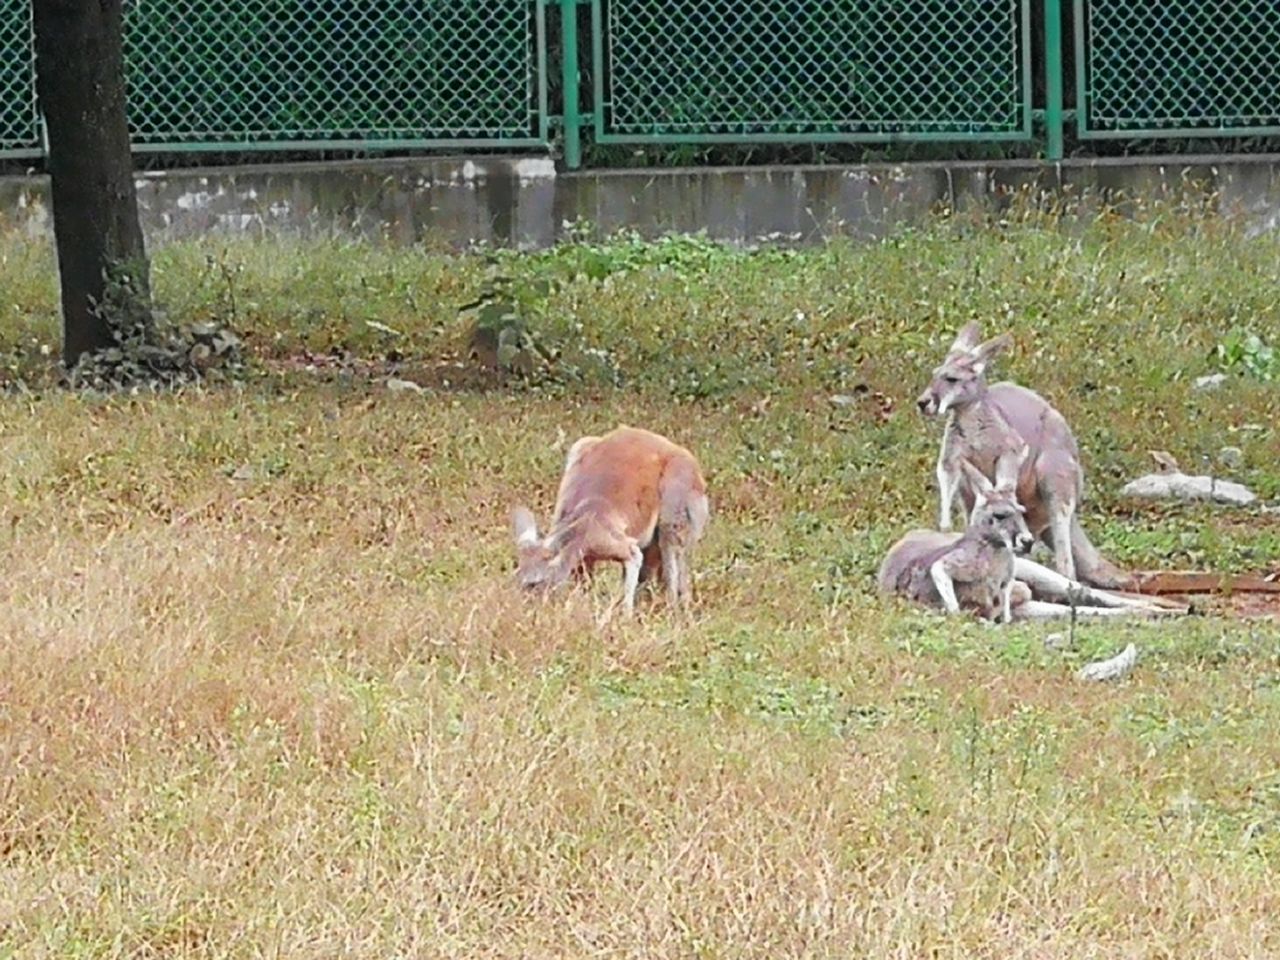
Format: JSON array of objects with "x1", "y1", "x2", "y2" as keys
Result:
[{"x1": 0, "y1": 156, "x2": 1280, "y2": 248}]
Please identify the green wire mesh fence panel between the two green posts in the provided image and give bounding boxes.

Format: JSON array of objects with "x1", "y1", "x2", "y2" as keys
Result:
[{"x1": 594, "y1": 0, "x2": 1030, "y2": 141}]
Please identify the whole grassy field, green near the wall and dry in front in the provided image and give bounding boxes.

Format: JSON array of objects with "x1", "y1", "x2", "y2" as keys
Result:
[{"x1": 0, "y1": 199, "x2": 1280, "y2": 959}]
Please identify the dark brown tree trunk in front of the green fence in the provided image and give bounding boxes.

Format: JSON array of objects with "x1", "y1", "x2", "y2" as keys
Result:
[{"x1": 33, "y1": 0, "x2": 151, "y2": 367}]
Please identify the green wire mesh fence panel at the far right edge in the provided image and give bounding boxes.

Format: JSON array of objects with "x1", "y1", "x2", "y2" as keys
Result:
[{"x1": 1075, "y1": 0, "x2": 1280, "y2": 137}]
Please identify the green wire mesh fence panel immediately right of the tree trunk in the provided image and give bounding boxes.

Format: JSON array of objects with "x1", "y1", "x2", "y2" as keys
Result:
[{"x1": 124, "y1": 0, "x2": 545, "y2": 148}]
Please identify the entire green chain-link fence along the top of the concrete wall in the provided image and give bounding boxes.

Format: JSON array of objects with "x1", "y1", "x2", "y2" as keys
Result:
[{"x1": 0, "y1": 0, "x2": 1280, "y2": 157}]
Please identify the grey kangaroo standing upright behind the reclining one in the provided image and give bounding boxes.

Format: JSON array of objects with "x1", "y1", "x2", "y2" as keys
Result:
[{"x1": 916, "y1": 323, "x2": 1129, "y2": 589}]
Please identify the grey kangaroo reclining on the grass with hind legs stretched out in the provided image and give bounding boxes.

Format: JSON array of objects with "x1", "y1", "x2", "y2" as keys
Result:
[{"x1": 877, "y1": 447, "x2": 1180, "y2": 623}]
